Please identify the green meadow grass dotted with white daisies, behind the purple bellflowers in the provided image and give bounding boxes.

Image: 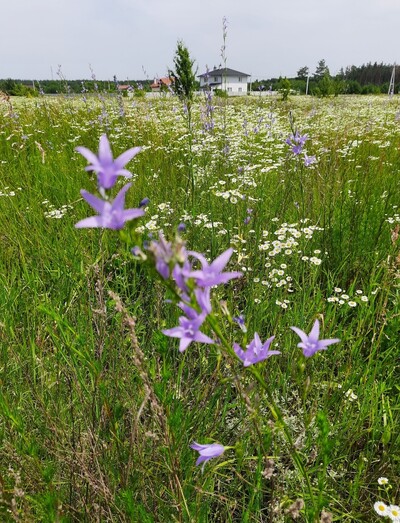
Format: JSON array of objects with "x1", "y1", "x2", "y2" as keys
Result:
[{"x1": 0, "y1": 92, "x2": 400, "y2": 523}]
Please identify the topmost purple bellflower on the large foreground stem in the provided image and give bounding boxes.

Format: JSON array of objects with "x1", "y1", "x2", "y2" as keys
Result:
[{"x1": 75, "y1": 134, "x2": 141, "y2": 191}]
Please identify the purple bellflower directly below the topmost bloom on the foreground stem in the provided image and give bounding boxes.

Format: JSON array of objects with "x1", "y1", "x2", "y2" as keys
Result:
[{"x1": 75, "y1": 183, "x2": 144, "y2": 230}]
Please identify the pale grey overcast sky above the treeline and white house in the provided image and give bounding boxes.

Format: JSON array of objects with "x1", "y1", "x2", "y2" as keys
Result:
[{"x1": 0, "y1": 0, "x2": 400, "y2": 82}]
